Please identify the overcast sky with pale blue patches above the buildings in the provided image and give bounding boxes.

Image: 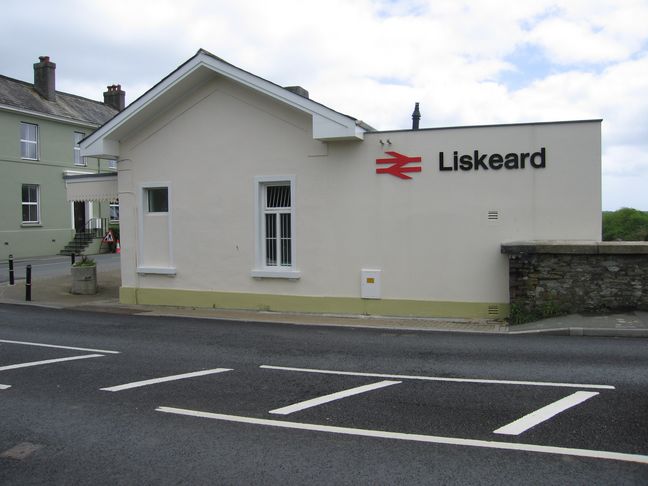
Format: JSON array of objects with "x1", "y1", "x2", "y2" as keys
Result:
[{"x1": 0, "y1": 0, "x2": 648, "y2": 210}]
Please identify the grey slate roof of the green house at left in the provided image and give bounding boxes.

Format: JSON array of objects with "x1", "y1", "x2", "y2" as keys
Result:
[{"x1": 0, "y1": 75, "x2": 118, "y2": 127}]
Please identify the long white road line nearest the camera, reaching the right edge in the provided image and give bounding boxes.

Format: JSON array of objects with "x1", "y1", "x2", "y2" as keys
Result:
[{"x1": 155, "y1": 407, "x2": 648, "y2": 464}]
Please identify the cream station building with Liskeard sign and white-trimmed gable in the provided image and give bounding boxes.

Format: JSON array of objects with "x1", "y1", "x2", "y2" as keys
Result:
[{"x1": 81, "y1": 50, "x2": 601, "y2": 318}]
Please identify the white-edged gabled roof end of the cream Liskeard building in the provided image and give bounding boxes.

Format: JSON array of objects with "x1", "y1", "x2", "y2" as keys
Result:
[{"x1": 81, "y1": 49, "x2": 374, "y2": 158}]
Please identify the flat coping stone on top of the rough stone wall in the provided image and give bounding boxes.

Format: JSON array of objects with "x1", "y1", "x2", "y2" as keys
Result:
[{"x1": 501, "y1": 240, "x2": 648, "y2": 255}]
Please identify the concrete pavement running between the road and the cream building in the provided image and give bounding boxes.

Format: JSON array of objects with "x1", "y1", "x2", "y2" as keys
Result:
[{"x1": 0, "y1": 255, "x2": 648, "y2": 337}]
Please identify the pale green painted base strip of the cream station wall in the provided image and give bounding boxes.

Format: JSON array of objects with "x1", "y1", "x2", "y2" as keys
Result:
[{"x1": 119, "y1": 287, "x2": 509, "y2": 319}]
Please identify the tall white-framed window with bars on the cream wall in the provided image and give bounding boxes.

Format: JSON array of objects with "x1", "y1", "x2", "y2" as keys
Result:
[{"x1": 252, "y1": 176, "x2": 300, "y2": 278}]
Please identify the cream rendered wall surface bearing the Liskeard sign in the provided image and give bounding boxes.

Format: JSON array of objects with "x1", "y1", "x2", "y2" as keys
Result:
[{"x1": 119, "y1": 79, "x2": 601, "y2": 303}]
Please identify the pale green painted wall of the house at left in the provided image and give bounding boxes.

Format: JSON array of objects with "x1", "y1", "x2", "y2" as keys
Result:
[{"x1": 0, "y1": 109, "x2": 112, "y2": 260}]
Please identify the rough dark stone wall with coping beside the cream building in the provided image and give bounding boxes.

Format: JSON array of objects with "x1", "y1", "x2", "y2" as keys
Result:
[{"x1": 502, "y1": 241, "x2": 648, "y2": 323}]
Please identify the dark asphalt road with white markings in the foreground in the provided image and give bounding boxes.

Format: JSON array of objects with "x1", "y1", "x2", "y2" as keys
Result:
[{"x1": 0, "y1": 306, "x2": 648, "y2": 485}]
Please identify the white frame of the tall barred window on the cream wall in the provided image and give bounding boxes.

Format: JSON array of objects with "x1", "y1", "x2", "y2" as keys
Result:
[{"x1": 251, "y1": 175, "x2": 301, "y2": 279}]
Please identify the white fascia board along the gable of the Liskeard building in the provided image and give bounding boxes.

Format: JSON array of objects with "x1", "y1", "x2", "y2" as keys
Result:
[{"x1": 80, "y1": 53, "x2": 365, "y2": 154}]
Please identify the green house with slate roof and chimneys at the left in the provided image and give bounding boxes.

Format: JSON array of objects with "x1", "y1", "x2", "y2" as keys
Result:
[{"x1": 0, "y1": 56, "x2": 125, "y2": 259}]
